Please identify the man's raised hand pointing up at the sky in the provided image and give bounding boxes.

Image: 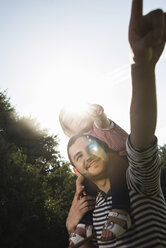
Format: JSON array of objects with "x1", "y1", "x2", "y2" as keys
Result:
[{"x1": 129, "y1": 0, "x2": 166, "y2": 67}]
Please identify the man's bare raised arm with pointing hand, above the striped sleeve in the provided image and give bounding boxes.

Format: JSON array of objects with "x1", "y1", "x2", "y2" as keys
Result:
[{"x1": 129, "y1": 0, "x2": 166, "y2": 149}]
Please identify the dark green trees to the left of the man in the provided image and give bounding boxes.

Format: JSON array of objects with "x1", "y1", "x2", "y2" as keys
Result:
[{"x1": 0, "y1": 93, "x2": 75, "y2": 248}]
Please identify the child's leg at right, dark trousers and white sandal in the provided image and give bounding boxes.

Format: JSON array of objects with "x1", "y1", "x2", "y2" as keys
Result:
[{"x1": 101, "y1": 159, "x2": 131, "y2": 240}]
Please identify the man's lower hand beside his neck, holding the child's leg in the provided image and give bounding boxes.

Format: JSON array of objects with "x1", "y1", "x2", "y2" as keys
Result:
[{"x1": 66, "y1": 176, "x2": 95, "y2": 234}]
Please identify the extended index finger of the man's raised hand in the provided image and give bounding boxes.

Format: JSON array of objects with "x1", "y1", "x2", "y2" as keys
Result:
[{"x1": 130, "y1": 0, "x2": 143, "y2": 26}]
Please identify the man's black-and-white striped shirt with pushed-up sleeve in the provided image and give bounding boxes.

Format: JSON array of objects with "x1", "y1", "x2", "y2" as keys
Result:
[{"x1": 93, "y1": 139, "x2": 166, "y2": 248}]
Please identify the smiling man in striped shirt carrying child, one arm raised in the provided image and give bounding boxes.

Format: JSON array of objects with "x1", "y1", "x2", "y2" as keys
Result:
[{"x1": 67, "y1": 0, "x2": 166, "y2": 248}]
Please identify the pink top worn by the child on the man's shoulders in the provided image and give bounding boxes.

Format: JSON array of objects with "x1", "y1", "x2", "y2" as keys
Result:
[{"x1": 89, "y1": 119, "x2": 128, "y2": 156}]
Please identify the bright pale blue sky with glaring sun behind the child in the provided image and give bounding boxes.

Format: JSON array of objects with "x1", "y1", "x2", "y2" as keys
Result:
[{"x1": 0, "y1": 0, "x2": 166, "y2": 159}]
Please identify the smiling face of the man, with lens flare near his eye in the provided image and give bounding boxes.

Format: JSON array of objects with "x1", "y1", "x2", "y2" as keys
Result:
[{"x1": 69, "y1": 136, "x2": 109, "y2": 180}]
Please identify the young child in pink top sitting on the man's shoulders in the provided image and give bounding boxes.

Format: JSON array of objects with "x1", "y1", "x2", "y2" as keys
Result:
[{"x1": 59, "y1": 104, "x2": 131, "y2": 248}]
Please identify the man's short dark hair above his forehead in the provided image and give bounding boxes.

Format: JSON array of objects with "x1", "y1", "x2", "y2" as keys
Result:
[{"x1": 67, "y1": 134, "x2": 113, "y2": 167}]
